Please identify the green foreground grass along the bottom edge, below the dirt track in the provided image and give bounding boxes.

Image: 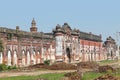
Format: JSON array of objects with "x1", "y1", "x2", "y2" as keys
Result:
[{"x1": 0, "y1": 71, "x2": 120, "y2": 80}]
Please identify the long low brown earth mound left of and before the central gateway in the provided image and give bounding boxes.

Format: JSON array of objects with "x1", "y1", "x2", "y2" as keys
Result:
[{"x1": 19, "y1": 62, "x2": 77, "y2": 71}]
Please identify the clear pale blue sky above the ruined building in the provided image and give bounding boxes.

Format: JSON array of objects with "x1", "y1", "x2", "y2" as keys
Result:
[{"x1": 0, "y1": 0, "x2": 120, "y2": 41}]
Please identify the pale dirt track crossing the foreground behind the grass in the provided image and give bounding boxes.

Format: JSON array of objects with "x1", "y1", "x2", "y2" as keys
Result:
[{"x1": 0, "y1": 62, "x2": 120, "y2": 78}]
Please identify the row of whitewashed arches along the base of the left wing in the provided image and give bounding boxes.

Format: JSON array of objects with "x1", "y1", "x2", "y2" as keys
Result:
[{"x1": 0, "y1": 50, "x2": 41, "y2": 66}]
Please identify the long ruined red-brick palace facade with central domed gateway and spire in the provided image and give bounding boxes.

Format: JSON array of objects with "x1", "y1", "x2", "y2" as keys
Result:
[{"x1": 0, "y1": 19, "x2": 103, "y2": 66}]
